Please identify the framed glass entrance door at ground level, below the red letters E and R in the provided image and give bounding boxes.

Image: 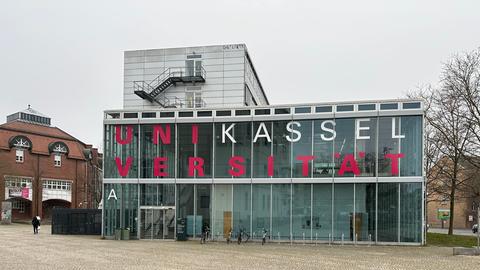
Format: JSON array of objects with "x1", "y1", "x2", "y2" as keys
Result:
[{"x1": 140, "y1": 206, "x2": 175, "y2": 239}]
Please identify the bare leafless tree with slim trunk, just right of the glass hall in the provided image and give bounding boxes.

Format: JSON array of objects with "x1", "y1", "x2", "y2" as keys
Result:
[{"x1": 425, "y1": 84, "x2": 474, "y2": 234}]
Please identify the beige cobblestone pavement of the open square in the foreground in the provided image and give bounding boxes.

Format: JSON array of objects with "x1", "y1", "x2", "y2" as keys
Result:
[{"x1": 0, "y1": 224, "x2": 480, "y2": 270}]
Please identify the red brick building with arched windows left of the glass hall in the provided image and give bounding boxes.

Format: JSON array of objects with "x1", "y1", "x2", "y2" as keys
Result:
[{"x1": 0, "y1": 106, "x2": 102, "y2": 220}]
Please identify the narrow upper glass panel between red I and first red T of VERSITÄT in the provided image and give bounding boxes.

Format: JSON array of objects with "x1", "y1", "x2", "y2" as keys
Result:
[{"x1": 273, "y1": 121, "x2": 292, "y2": 178}]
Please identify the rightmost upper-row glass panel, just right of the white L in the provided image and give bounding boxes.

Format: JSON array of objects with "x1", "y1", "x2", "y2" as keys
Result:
[{"x1": 399, "y1": 116, "x2": 423, "y2": 176}]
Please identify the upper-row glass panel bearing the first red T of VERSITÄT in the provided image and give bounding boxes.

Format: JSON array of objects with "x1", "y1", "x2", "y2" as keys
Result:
[{"x1": 290, "y1": 120, "x2": 313, "y2": 178}]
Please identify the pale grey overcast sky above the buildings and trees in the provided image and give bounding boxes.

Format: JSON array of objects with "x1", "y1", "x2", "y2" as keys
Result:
[{"x1": 0, "y1": 0, "x2": 480, "y2": 150}]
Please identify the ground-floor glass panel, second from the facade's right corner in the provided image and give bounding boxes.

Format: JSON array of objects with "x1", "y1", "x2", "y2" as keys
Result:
[{"x1": 377, "y1": 183, "x2": 398, "y2": 242}]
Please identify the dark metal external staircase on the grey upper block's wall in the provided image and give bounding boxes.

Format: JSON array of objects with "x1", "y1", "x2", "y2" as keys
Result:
[{"x1": 133, "y1": 67, "x2": 206, "y2": 107}]
